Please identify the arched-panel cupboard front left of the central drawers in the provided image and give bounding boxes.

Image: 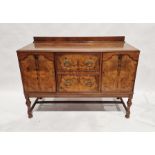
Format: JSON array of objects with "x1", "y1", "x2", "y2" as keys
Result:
[{"x1": 18, "y1": 53, "x2": 56, "y2": 92}]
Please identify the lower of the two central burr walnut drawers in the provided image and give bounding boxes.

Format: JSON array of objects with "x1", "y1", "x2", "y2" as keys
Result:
[{"x1": 58, "y1": 75, "x2": 99, "y2": 92}]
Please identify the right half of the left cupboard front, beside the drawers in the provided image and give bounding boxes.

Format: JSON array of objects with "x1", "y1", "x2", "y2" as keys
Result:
[{"x1": 38, "y1": 53, "x2": 56, "y2": 92}]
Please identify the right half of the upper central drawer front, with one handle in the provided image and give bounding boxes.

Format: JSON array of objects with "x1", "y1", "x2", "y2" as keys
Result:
[{"x1": 78, "y1": 54, "x2": 100, "y2": 72}]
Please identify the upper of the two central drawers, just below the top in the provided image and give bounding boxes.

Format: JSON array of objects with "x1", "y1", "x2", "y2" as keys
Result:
[{"x1": 56, "y1": 53, "x2": 100, "y2": 72}]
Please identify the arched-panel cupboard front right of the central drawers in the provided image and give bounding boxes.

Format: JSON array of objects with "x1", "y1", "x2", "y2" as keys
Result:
[{"x1": 102, "y1": 52, "x2": 138, "y2": 93}]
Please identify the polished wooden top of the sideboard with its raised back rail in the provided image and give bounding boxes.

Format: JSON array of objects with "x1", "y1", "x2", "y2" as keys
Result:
[{"x1": 17, "y1": 36, "x2": 139, "y2": 52}]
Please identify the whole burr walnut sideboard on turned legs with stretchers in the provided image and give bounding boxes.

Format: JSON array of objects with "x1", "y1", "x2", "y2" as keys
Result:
[{"x1": 17, "y1": 36, "x2": 140, "y2": 118}]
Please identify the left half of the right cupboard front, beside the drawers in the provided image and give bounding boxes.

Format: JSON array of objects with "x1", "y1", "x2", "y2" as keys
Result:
[{"x1": 102, "y1": 53, "x2": 118, "y2": 92}]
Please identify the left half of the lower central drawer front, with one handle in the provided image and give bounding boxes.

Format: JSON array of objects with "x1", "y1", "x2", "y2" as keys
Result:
[{"x1": 58, "y1": 75, "x2": 79, "y2": 92}]
